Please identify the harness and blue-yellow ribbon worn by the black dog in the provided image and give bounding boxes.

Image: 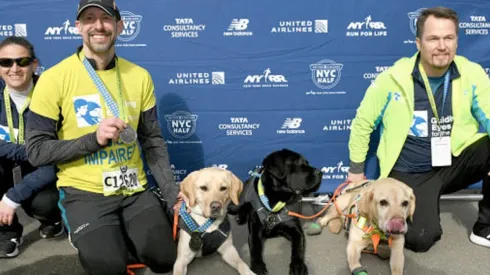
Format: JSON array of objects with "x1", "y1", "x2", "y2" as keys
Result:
[{"x1": 244, "y1": 166, "x2": 301, "y2": 231}]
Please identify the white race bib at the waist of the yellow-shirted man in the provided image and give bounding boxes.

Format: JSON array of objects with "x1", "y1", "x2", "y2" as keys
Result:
[{"x1": 102, "y1": 166, "x2": 143, "y2": 196}]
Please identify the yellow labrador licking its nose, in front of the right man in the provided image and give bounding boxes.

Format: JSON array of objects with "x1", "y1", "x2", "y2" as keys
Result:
[{"x1": 318, "y1": 178, "x2": 415, "y2": 275}]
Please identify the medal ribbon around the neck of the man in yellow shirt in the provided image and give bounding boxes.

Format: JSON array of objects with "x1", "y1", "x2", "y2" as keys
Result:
[{"x1": 83, "y1": 57, "x2": 127, "y2": 122}]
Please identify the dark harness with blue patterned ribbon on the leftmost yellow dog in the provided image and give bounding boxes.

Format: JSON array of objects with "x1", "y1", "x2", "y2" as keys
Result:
[{"x1": 179, "y1": 203, "x2": 231, "y2": 256}]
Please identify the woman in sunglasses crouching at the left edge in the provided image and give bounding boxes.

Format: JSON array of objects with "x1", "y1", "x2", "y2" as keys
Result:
[{"x1": 0, "y1": 37, "x2": 64, "y2": 258}]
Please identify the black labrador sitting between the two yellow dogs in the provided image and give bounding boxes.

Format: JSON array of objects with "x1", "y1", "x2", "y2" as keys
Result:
[{"x1": 228, "y1": 149, "x2": 322, "y2": 275}]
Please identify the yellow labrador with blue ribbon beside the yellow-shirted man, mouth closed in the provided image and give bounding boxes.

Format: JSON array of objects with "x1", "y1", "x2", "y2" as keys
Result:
[{"x1": 173, "y1": 167, "x2": 254, "y2": 275}]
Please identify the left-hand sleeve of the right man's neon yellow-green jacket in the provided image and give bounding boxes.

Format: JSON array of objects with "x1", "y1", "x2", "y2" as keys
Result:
[{"x1": 349, "y1": 71, "x2": 390, "y2": 174}]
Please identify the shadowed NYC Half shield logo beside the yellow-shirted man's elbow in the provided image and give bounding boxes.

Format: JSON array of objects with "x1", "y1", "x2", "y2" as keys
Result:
[{"x1": 165, "y1": 111, "x2": 198, "y2": 139}]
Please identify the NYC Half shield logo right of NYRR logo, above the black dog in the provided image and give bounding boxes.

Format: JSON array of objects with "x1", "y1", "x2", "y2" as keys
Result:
[{"x1": 310, "y1": 59, "x2": 344, "y2": 89}]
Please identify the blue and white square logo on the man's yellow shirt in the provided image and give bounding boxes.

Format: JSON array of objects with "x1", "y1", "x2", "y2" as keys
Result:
[{"x1": 73, "y1": 94, "x2": 102, "y2": 128}]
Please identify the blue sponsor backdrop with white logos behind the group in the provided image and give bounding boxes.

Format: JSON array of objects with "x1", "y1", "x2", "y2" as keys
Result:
[{"x1": 0, "y1": 0, "x2": 490, "y2": 192}]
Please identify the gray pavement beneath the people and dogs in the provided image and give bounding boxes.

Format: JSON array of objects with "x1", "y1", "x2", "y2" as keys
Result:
[{"x1": 0, "y1": 201, "x2": 490, "y2": 275}]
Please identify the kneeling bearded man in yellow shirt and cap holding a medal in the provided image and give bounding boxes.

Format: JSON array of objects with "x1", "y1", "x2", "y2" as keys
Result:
[{"x1": 26, "y1": 0, "x2": 183, "y2": 275}]
